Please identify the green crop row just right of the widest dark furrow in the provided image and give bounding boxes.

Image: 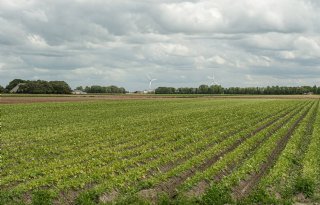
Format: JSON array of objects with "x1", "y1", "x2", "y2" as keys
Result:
[{"x1": 259, "y1": 102, "x2": 319, "y2": 201}]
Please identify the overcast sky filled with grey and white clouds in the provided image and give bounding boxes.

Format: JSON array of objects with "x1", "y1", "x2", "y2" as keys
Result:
[{"x1": 0, "y1": 0, "x2": 320, "y2": 91}]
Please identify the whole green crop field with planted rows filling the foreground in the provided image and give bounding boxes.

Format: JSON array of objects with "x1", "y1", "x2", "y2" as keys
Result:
[{"x1": 0, "y1": 97, "x2": 320, "y2": 204}]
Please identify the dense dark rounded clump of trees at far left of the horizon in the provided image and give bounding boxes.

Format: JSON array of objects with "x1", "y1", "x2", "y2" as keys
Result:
[{"x1": 5, "y1": 79, "x2": 72, "y2": 94}]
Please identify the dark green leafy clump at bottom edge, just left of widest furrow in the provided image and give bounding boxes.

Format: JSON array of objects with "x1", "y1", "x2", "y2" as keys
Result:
[{"x1": 201, "y1": 185, "x2": 232, "y2": 205}]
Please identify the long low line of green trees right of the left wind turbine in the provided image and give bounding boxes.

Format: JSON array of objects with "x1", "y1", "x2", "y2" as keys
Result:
[{"x1": 155, "y1": 85, "x2": 320, "y2": 95}]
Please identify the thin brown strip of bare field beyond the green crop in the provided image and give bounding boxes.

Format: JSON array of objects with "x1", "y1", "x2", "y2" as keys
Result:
[{"x1": 0, "y1": 94, "x2": 320, "y2": 104}]
